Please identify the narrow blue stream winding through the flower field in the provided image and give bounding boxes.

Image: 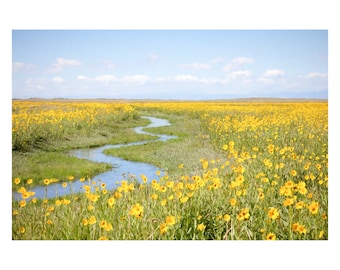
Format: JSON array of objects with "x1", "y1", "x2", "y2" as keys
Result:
[{"x1": 13, "y1": 116, "x2": 177, "y2": 200}]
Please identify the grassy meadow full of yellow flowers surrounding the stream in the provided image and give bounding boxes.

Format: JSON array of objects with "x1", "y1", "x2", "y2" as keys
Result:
[{"x1": 12, "y1": 100, "x2": 328, "y2": 240}]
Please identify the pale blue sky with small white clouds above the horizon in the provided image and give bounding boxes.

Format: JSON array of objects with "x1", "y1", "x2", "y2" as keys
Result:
[{"x1": 12, "y1": 30, "x2": 328, "y2": 99}]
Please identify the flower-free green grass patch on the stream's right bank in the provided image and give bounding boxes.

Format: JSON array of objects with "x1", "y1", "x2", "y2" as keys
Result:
[{"x1": 104, "y1": 115, "x2": 223, "y2": 174}]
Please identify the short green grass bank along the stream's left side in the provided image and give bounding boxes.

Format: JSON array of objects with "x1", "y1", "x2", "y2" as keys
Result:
[{"x1": 12, "y1": 118, "x2": 156, "y2": 189}]
